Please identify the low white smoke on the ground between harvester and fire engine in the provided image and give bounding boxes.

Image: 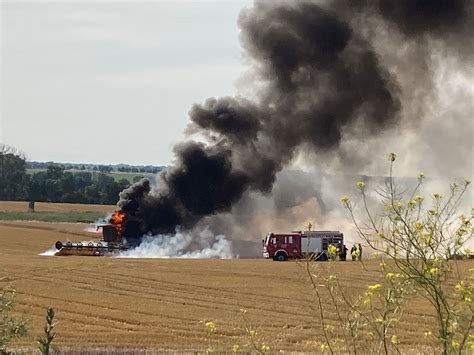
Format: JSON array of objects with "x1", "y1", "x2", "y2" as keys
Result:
[{"x1": 117, "y1": 228, "x2": 234, "y2": 259}]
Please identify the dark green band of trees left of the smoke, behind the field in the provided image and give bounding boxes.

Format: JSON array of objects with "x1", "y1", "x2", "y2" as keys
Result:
[{"x1": 0, "y1": 144, "x2": 130, "y2": 208}]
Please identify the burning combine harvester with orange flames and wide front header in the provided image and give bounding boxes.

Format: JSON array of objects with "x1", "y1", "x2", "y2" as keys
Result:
[{"x1": 54, "y1": 211, "x2": 130, "y2": 256}]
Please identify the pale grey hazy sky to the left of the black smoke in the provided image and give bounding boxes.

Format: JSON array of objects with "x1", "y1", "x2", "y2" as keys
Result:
[{"x1": 0, "y1": 0, "x2": 251, "y2": 165}]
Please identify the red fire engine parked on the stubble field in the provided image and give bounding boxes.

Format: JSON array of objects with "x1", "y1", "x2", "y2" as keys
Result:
[{"x1": 263, "y1": 231, "x2": 344, "y2": 261}]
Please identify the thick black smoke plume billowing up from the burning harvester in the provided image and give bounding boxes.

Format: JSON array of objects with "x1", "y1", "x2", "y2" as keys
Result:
[{"x1": 118, "y1": 0, "x2": 472, "y2": 241}]
